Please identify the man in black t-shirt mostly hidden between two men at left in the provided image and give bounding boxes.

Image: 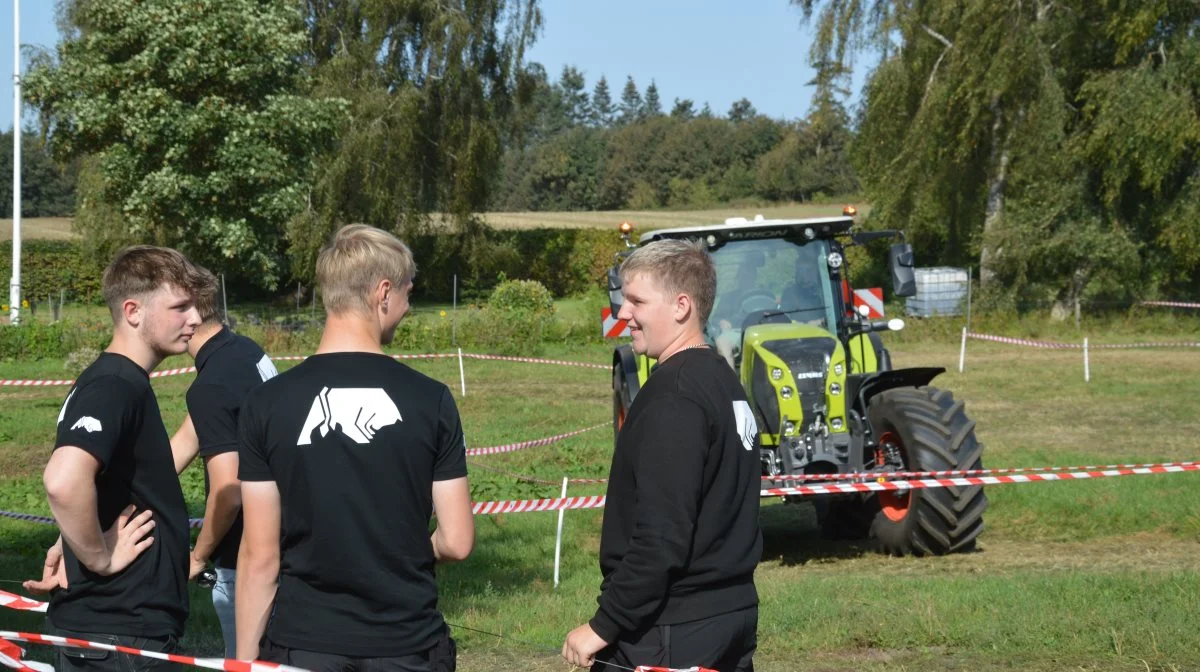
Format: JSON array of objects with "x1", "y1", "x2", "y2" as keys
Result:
[{"x1": 170, "y1": 266, "x2": 276, "y2": 658}]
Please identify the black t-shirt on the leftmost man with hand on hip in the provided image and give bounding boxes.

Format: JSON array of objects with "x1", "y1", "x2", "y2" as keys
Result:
[{"x1": 49, "y1": 353, "x2": 188, "y2": 637}]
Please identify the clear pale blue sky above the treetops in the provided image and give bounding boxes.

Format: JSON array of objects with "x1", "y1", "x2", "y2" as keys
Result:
[{"x1": 0, "y1": 0, "x2": 869, "y2": 130}]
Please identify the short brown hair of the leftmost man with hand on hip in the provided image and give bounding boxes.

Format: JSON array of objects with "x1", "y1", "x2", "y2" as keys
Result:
[{"x1": 100, "y1": 245, "x2": 196, "y2": 320}]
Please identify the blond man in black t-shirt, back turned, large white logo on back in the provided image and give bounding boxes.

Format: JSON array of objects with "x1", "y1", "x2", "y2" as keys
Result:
[{"x1": 238, "y1": 224, "x2": 474, "y2": 672}]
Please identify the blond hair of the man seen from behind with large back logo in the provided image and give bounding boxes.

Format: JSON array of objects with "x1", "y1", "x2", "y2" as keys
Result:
[{"x1": 317, "y1": 224, "x2": 416, "y2": 314}]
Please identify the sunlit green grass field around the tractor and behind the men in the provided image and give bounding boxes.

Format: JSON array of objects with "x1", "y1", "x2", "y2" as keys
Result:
[{"x1": 0, "y1": 342, "x2": 1200, "y2": 672}]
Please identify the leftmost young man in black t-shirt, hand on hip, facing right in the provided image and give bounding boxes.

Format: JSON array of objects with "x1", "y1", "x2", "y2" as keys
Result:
[{"x1": 26, "y1": 246, "x2": 200, "y2": 672}]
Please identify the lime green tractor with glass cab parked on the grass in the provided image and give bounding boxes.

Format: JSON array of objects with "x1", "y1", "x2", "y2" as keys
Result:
[{"x1": 608, "y1": 208, "x2": 988, "y2": 556}]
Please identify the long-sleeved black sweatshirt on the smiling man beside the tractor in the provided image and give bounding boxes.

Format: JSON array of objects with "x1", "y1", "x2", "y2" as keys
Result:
[{"x1": 590, "y1": 348, "x2": 762, "y2": 643}]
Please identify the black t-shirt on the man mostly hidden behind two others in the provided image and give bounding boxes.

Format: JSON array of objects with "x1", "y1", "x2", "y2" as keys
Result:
[{"x1": 187, "y1": 328, "x2": 277, "y2": 569}]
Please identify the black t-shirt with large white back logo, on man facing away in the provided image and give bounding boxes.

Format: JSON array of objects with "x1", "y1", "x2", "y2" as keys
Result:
[{"x1": 239, "y1": 353, "x2": 467, "y2": 658}]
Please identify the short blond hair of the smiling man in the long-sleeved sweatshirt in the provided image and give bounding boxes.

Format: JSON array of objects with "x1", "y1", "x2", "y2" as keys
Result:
[{"x1": 620, "y1": 239, "x2": 716, "y2": 328}]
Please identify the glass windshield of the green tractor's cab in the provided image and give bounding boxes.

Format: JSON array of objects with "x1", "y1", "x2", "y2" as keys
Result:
[{"x1": 709, "y1": 239, "x2": 835, "y2": 337}]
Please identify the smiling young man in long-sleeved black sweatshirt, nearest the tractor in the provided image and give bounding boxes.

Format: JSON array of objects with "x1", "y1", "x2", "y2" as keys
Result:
[{"x1": 563, "y1": 240, "x2": 762, "y2": 672}]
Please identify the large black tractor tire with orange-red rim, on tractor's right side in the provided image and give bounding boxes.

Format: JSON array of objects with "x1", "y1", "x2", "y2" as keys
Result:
[{"x1": 864, "y1": 386, "x2": 988, "y2": 556}]
